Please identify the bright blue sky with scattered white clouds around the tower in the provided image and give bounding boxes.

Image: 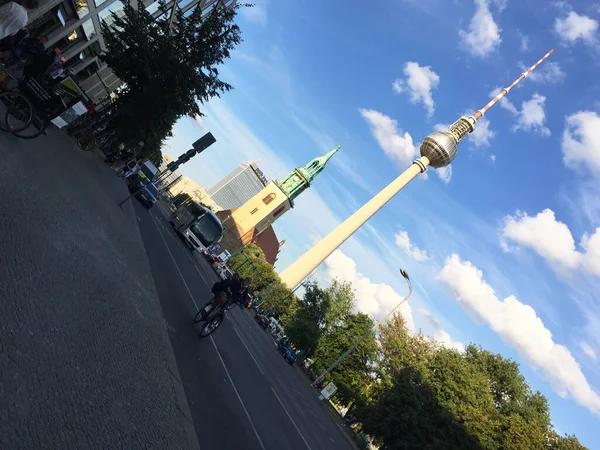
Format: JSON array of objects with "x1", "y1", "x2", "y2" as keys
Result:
[{"x1": 164, "y1": 0, "x2": 600, "y2": 447}]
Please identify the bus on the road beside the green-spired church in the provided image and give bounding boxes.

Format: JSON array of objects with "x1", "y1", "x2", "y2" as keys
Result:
[{"x1": 169, "y1": 201, "x2": 223, "y2": 251}]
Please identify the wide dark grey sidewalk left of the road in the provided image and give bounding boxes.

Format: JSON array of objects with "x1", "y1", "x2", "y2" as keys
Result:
[{"x1": 0, "y1": 130, "x2": 198, "y2": 450}]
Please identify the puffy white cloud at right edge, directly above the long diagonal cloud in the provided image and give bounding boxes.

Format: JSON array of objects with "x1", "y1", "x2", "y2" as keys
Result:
[{"x1": 501, "y1": 209, "x2": 600, "y2": 276}]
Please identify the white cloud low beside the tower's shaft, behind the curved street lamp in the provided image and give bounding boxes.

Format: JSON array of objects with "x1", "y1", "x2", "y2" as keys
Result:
[{"x1": 325, "y1": 250, "x2": 415, "y2": 332}]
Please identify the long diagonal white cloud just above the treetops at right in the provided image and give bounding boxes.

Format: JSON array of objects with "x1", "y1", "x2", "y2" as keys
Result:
[{"x1": 439, "y1": 254, "x2": 600, "y2": 414}]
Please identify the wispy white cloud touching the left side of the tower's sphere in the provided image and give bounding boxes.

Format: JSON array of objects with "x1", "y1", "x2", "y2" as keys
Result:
[{"x1": 359, "y1": 109, "x2": 417, "y2": 168}]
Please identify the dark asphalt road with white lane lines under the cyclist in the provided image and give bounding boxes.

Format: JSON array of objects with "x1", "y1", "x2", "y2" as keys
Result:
[{"x1": 134, "y1": 201, "x2": 354, "y2": 450}]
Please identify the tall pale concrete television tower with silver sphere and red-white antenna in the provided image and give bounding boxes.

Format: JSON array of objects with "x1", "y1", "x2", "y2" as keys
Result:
[{"x1": 280, "y1": 50, "x2": 554, "y2": 289}]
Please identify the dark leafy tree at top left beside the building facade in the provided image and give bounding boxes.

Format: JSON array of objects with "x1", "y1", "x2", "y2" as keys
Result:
[{"x1": 100, "y1": 2, "x2": 248, "y2": 156}]
